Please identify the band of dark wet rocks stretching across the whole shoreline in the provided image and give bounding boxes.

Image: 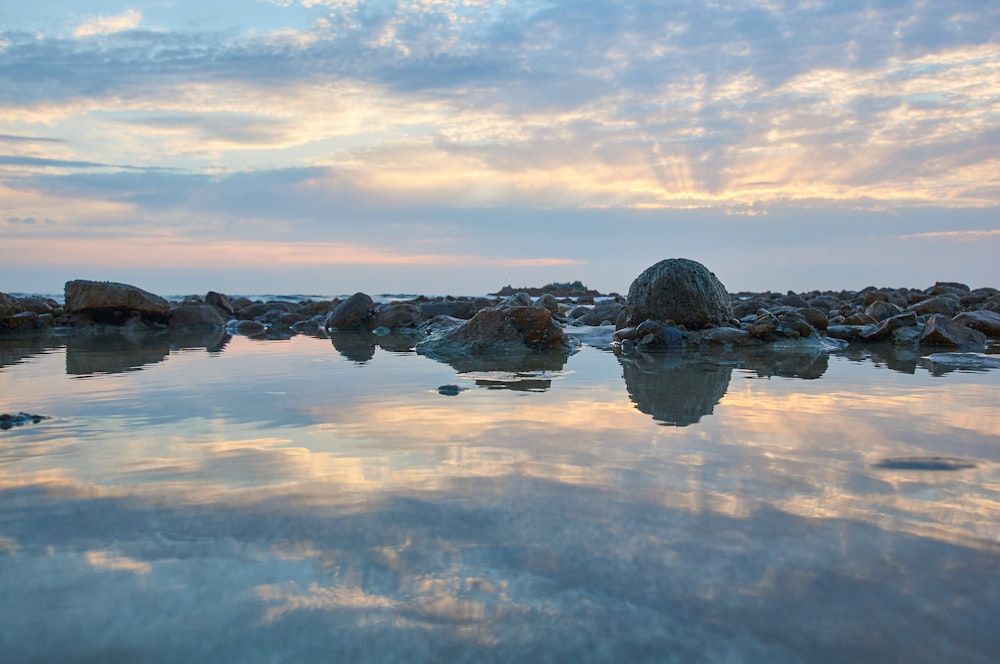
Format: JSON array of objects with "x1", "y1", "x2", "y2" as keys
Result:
[{"x1": 0, "y1": 259, "x2": 1000, "y2": 360}]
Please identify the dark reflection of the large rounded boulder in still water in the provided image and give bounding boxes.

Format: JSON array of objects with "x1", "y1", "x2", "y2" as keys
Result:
[{"x1": 618, "y1": 352, "x2": 733, "y2": 427}]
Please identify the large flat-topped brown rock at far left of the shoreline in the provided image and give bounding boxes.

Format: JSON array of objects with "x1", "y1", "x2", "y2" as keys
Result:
[{"x1": 65, "y1": 280, "x2": 170, "y2": 325}]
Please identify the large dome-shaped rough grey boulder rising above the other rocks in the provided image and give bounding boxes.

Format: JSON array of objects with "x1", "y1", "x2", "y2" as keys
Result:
[{"x1": 621, "y1": 258, "x2": 733, "y2": 330}]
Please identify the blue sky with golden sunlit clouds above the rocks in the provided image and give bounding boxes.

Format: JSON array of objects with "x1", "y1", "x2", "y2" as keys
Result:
[{"x1": 0, "y1": 0, "x2": 1000, "y2": 295}]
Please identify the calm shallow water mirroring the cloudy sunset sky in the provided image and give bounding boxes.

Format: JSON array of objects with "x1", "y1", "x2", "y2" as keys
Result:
[{"x1": 0, "y1": 334, "x2": 1000, "y2": 662}]
